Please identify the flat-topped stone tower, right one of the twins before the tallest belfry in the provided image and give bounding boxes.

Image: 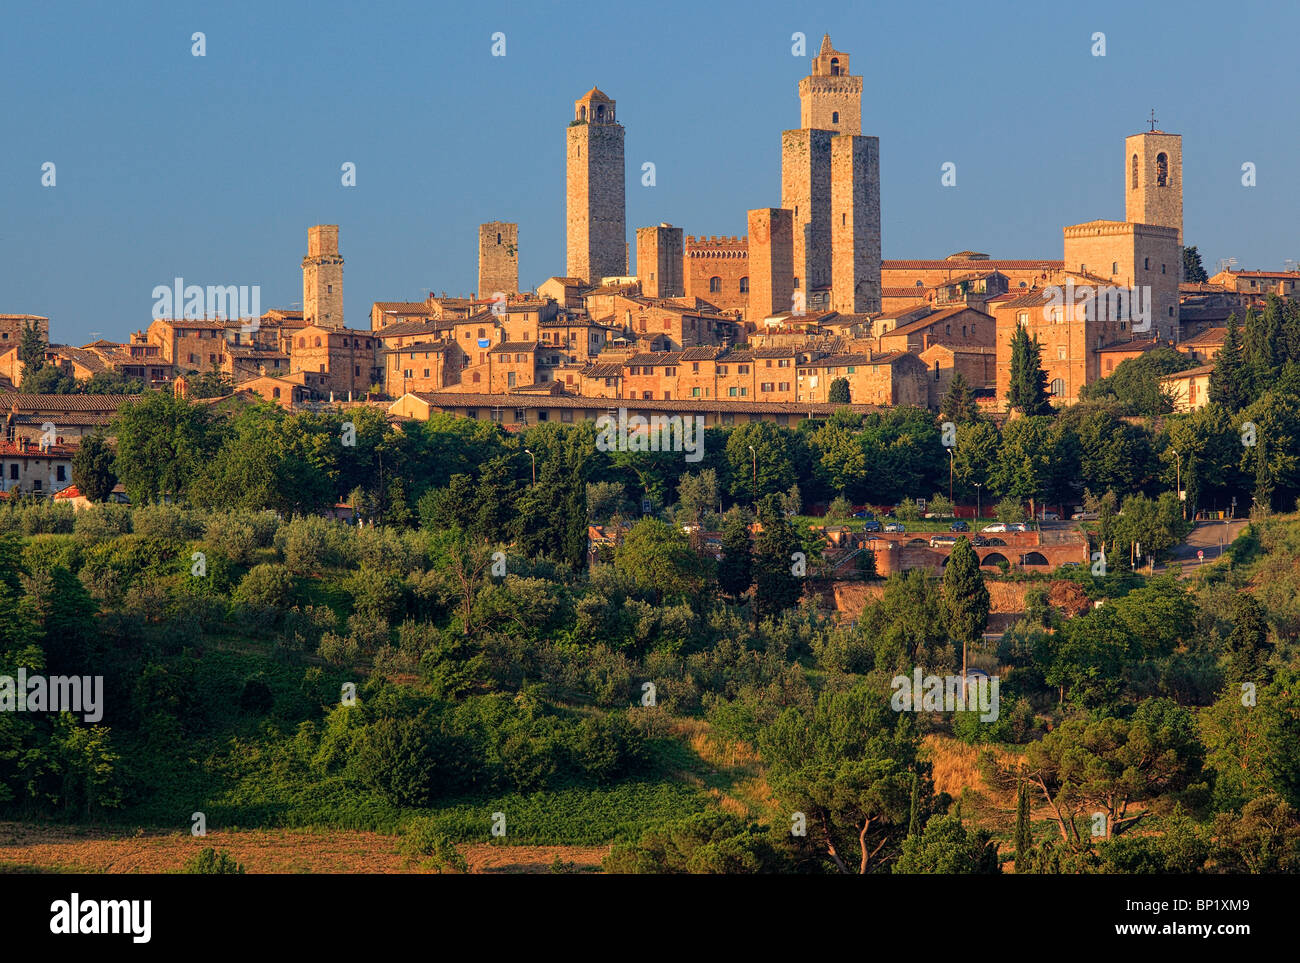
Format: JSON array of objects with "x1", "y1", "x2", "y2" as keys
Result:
[{"x1": 831, "y1": 134, "x2": 881, "y2": 315}]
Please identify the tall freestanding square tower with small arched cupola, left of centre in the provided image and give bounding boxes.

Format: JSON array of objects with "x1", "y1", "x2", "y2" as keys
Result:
[{"x1": 566, "y1": 87, "x2": 628, "y2": 282}]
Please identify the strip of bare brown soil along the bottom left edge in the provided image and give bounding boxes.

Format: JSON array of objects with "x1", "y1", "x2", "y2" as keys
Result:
[{"x1": 0, "y1": 823, "x2": 608, "y2": 873}]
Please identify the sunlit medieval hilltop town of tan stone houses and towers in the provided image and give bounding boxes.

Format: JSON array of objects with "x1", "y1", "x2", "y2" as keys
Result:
[{"x1": 0, "y1": 36, "x2": 1300, "y2": 494}]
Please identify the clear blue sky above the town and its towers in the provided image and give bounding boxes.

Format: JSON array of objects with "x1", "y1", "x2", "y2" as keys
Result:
[{"x1": 0, "y1": 0, "x2": 1300, "y2": 344}]
